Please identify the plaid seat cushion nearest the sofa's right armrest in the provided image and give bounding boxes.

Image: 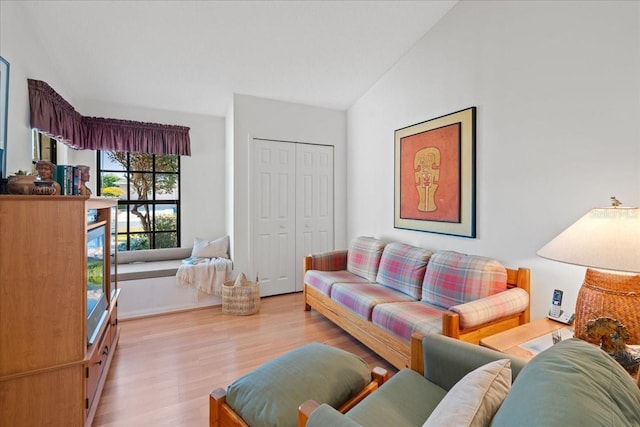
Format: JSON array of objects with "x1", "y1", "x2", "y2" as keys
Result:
[{"x1": 371, "y1": 301, "x2": 444, "y2": 342}]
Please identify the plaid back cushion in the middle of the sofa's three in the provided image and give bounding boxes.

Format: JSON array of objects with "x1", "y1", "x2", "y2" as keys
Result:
[{"x1": 376, "y1": 243, "x2": 433, "y2": 299}]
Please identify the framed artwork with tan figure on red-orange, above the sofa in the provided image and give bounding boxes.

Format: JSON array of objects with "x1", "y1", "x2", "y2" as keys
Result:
[{"x1": 394, "y1": 107, "x2": 476, "y2": 237}]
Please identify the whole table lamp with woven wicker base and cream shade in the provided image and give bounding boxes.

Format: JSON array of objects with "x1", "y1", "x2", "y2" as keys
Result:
[{"x1": 538, "y1": 197, "x2": 640, "y2": 344}]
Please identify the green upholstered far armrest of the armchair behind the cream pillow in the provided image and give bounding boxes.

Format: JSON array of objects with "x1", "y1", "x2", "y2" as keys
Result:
[{"x1": 422, "y1": 334, "x2": 527, "y2": 390}]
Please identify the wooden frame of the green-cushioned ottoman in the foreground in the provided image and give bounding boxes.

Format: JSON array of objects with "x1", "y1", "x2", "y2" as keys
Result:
[{"x1": 209, "y1": 367, "x2": 390, "y2": 427}]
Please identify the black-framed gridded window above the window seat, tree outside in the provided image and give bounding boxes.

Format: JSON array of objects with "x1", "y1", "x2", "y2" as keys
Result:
[{"x1": 98, "y1": 151, "x2": 180, "y2": 251}]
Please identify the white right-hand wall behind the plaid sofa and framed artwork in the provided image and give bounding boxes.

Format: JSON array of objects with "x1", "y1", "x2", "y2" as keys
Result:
[{"x1": 347, "y1": 1, "x2": 640, "y2": 318}]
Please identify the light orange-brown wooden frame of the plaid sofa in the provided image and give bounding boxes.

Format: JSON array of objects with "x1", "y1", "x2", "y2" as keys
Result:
[{"x1": 303, "y1": 256, "x2": 531, "y2": 369}]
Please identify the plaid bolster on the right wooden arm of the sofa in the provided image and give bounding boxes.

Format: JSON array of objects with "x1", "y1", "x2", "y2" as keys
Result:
[{"x1": 450, "y1": 288, "x2": 529, "y2": 328}]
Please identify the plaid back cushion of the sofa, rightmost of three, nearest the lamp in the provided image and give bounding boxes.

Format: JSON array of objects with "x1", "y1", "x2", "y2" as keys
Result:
[{"x1": 422, "y1": 251, "x2": 507, "y2": 309}]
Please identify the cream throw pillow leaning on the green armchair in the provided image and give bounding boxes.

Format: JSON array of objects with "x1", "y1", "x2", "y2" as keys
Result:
[{"x1": 423, "y1": 359, "x2": 511, "y2": 427}]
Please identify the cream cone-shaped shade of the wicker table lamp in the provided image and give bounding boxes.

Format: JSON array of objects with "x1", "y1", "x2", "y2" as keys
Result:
[{"x1": 538, "y1": 207, "x2": 640, "y2": 274}]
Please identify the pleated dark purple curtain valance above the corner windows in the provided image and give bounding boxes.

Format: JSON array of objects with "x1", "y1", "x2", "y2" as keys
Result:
[{"x1": 28, "y1": 79, "x2": 191, "y2": 156}]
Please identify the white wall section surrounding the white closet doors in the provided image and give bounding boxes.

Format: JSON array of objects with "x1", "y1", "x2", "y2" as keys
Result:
[{"x1": 227, "y1": 95, "x2": 347, "y2": 277}]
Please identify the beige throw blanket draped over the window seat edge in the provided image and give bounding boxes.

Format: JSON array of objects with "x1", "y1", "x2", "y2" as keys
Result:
[{"x1": 176, "y1": 258, "x2": 233, "y2": 295}]
